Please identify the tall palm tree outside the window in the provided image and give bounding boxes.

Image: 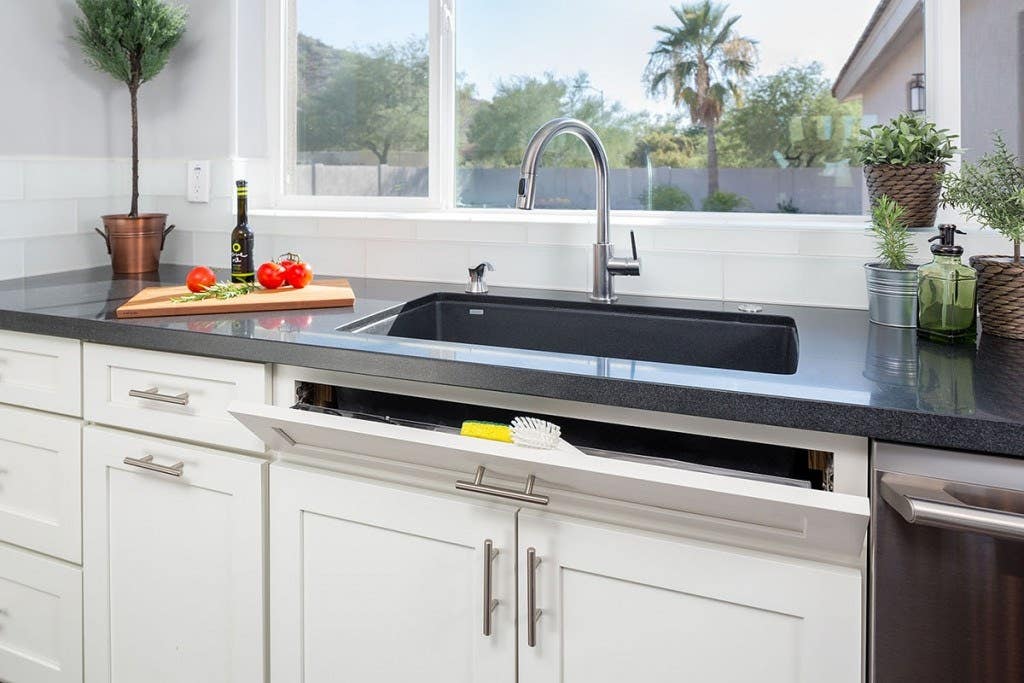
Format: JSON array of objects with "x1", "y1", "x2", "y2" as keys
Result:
[{"x1": 644, "y1": 0, "x2": 757, "y2": 196}]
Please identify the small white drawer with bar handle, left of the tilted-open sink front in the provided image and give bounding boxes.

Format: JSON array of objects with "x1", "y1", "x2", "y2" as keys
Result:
[{"x1": 84, "y1": 344, "x2": 270, "y2": 452}]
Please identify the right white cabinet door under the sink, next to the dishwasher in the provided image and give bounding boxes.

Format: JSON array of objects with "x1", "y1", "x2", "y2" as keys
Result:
[{"x1": 519, "y1": 511, "x2": 862, "y2": 683}]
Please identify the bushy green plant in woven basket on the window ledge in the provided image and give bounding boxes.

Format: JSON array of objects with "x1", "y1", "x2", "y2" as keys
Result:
[{"x1": 856, "y1": 114, "x2": 956, "y2": 227}]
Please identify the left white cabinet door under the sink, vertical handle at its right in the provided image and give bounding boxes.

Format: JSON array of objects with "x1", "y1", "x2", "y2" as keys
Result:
[{"x1": 270, "y1": 463, "x2": 515, "y2": 683}]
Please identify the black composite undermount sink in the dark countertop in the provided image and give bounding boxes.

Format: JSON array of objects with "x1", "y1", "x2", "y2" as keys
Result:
[{"x1": 339, "y1": 293, "x2": 799, "y2": 375}]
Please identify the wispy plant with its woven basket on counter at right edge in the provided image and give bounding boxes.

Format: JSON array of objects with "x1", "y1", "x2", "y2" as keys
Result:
[{"x1": 942, "y1": 133, "x2": 1024, "y2": 339}]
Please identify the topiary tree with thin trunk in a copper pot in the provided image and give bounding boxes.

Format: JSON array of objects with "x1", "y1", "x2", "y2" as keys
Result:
[{"x1": 75, "y1": 0, "x2": 188, "y2": 273}]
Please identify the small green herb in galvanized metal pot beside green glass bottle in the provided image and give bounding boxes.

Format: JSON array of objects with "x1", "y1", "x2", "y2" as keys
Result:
[{"x1": 864, "y1": 195, "x2": 918, "y2": 328}]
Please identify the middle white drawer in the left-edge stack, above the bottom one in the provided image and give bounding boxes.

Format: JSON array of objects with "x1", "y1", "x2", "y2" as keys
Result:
[{"x1": 0, "y1": 405, "x2": 82, "y2": 561}]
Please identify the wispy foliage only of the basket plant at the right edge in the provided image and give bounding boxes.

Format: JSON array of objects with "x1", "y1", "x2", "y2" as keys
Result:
[{"x1": 942, "y1": 132, "x2": 1024, "y2": 263}]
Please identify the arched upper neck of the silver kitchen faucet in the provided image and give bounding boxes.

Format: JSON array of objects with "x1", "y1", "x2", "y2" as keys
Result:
[{"x1": 516, "y1": 118, "x2": 610, "y2": 244}]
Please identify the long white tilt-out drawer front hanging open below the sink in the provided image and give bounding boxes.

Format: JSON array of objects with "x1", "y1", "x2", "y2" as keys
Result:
[{"x1": 230, "y1": 402, "x2": 869, "y2": 564}]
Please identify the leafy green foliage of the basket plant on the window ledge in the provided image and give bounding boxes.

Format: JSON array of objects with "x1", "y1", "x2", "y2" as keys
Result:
[{"x1": 855, "y1": 114, "x2": 957, "y2": 166}]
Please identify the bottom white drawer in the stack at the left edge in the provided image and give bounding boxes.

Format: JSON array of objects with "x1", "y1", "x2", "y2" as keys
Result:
[{"x1": 0, "y1": 546, "x2": 82, "y2": 683}]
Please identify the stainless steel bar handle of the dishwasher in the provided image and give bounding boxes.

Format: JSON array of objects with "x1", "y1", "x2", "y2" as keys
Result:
[{"x1": 879, "y1": 473, "x2": 1024, "y2": 541}]
